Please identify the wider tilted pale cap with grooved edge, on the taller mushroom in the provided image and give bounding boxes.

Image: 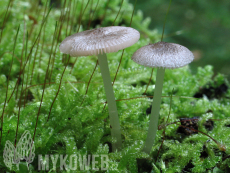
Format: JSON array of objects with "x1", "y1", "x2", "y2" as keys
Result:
[{"x1": 59, "y1": 26, "x2": 140, "y2": 56}]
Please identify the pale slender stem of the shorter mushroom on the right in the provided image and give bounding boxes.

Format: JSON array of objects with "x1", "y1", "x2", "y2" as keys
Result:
[{"x1": 143, "y1": 68, "x2": 165, "y2": 154}]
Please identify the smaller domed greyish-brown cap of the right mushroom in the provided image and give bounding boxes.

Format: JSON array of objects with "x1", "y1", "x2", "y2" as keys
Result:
[{"x1": 132, "y1": 42, "x2": 194, "y2": 68}]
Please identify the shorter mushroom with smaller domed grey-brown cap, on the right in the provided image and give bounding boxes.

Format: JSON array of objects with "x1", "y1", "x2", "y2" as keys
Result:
[{"x1": 132, "y1": 41, "x2": 194, "y2": 153}]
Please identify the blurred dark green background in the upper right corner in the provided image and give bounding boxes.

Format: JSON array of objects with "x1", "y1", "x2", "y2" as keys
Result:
[{"x1": 130, "y1": 0, "x2": 230, "y2": 79}]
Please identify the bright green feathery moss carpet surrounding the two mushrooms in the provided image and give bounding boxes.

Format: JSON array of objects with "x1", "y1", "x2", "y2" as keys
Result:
[{"x1": 0, "y1": 0, "x2": 230, "y2": 172}]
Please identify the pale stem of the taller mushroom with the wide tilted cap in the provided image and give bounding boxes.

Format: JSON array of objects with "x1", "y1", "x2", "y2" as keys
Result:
[{"x1": 98, "y1": 53, "x2": 121, "y2": 151}]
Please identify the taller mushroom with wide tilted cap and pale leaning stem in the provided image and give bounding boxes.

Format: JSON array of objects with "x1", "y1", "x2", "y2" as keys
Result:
[{"x1": 59, "y1": 26, "x2": 140, "y2": 151}]
